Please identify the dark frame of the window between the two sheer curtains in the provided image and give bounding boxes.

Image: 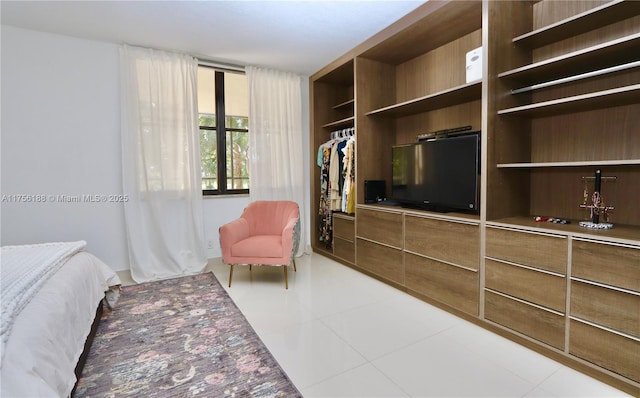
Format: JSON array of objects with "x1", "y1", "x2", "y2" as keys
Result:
[{"x1": 199, "y1": 65, "x2": 251, "y2": 196}]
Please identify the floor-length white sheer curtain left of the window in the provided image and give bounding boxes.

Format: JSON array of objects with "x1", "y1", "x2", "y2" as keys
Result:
[{"x1": 120, "y1": 45, "x2": 207, "y2": 282}]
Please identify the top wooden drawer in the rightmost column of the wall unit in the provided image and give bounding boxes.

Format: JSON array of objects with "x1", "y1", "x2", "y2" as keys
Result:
[{"x1": 571, "y1": 239, "x2": 640, "y2": 292}]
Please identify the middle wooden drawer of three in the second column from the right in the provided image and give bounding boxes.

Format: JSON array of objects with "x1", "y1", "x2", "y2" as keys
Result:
[{"x1": 485, "y1": 259, "x2": 567, "y2": 313}]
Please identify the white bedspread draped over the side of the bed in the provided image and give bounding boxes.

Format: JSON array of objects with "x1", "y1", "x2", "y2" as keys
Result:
[{"x1": 0, "y1": 247, "x2": 120, "y2": 398}]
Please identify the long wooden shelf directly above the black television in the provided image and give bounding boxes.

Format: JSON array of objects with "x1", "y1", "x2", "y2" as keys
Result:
[{"x1": 365, "y1": 81, "x2": 482, "y2": 117}]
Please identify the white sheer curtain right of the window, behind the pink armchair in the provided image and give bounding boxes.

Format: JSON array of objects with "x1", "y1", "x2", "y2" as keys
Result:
[{"x1": 245, "y1": 66, "x2": 310, "y2": 256}]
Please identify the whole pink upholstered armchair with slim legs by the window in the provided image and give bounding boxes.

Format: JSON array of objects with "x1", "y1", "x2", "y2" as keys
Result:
[{"x1": 219, "y1": 201, "x2": 300, "y2": 289}]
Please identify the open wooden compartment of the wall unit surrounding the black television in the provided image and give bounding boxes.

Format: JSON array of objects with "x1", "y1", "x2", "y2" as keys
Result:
[{"x1": 355, "y1": 1, "x2": 482, "y2": 199}]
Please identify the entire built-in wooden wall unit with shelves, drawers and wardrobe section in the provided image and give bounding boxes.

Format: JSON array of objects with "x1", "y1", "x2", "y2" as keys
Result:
[{"x1": 310, "y1": 0, "x2": 640, "y2": 395}]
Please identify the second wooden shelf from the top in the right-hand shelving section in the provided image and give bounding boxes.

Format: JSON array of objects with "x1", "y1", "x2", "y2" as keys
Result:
[{"x1": 498, "y1": 33, "x2": 640, "y2": 84}]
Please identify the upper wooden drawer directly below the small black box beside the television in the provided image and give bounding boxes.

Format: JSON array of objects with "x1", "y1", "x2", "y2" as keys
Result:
[{"x1": 356, "y1": 209, "x2": 404, "y2": 249}]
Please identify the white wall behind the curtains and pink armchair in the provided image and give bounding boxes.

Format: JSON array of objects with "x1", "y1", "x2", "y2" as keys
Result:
[{"x1": 0, "y1": 26, "x2": 309, "y2": 271}]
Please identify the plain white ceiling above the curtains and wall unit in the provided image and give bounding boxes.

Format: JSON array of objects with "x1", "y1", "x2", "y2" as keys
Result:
[{"x1": 0, "y1": 0, "x2": 424, "y2": 75}]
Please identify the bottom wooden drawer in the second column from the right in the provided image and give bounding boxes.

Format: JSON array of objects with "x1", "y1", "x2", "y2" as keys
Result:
[{"x1": 484, "y1": 291, "x2": 565, "y2": 350}]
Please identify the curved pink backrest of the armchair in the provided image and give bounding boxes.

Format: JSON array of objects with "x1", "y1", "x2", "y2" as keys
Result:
[{"x1": 241, "y1": 200, "x2": 300, "y2": 235}]
